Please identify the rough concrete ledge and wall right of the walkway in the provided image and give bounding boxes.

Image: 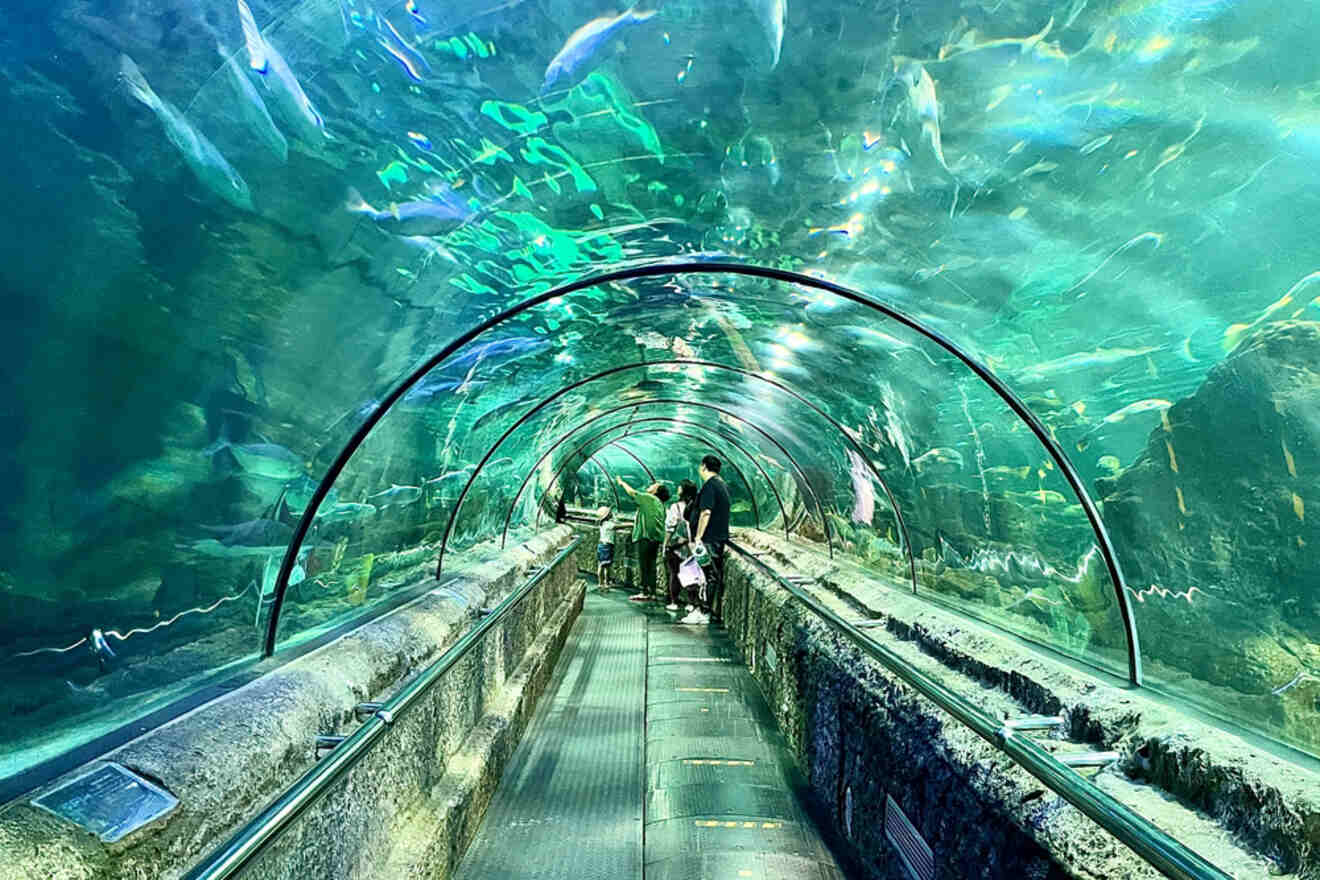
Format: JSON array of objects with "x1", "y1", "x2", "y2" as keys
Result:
[{"x1": 725, "y1": 533, "x2": 1320, "y2": 877}]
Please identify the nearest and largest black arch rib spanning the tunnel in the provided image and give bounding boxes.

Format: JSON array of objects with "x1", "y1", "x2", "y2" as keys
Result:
[{"x1": 264, "y1": 260, "x2": 1142, "y2": 686}]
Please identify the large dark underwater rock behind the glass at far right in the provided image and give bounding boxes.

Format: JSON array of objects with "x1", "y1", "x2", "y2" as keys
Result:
[{"x1": 1097, "y1": 321, "x2": 1320, "y2": 695}]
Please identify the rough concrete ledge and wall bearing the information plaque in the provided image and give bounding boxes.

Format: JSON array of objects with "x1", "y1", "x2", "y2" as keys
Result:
[{"x1": 0, "y1": 526, "x2": 579, "y2": 880}]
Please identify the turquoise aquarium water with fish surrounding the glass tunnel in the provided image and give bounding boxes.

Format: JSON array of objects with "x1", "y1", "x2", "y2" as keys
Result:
[{"x1": 0, "y1": 0, "x2": 1320, "y2": 776}]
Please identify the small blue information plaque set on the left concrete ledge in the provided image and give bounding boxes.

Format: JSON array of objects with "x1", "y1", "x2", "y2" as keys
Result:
[{"x1": 32, "y1": 764, "x2": 178, "y2": 843}]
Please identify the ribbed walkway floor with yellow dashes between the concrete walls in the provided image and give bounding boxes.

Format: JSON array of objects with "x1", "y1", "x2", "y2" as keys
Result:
[{"x1": 455, "y1": 588, "x2": 843, "y2": 880}]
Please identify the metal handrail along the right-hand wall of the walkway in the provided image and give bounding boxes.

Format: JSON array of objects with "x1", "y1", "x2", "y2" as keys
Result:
[{"x1": 729, "y1": 541, "x2": 1232, "y2": 880}]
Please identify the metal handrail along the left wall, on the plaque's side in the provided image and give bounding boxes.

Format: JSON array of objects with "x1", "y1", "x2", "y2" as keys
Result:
[{"x1": 183, "y1": 534, "x2": 582, "y2": 880}]
